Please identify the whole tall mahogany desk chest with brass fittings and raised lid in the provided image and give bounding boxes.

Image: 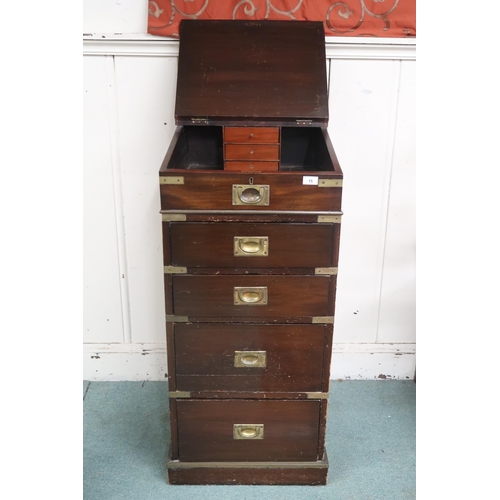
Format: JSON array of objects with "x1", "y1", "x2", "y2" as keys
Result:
[{"x1": 160, "y1": 21, "x2": 342, "y2": 484}]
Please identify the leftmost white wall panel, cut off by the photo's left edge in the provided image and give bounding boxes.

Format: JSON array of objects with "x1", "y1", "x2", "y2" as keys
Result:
[{"x1": 83, "y1": 56, "x2": 127, "y2": 343}]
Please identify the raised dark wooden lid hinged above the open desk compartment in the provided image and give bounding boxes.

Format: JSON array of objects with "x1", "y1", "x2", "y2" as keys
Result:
[{"x1": 175, "y1": 19, "x2": 328, "y2": 126}]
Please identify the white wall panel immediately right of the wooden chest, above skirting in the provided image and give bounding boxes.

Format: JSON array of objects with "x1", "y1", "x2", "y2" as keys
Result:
[{"x1": 329, "y1": 60, "x2": 399, "y2": 343}]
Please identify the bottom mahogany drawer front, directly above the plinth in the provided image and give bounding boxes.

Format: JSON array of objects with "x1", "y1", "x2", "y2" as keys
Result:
[{"x1": 177, "y1": 400, "x2": 320, "y2": 462}]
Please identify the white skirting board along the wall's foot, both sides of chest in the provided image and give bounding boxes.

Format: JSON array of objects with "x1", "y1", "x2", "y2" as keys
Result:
[{"x1": 83, "y1": 344, "x2": 415, "y2": 381}]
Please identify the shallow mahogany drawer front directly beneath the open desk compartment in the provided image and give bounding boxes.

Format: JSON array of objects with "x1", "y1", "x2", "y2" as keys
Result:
[{"x1": 168, "y1": 222, "x2": 339, "y2": 268}]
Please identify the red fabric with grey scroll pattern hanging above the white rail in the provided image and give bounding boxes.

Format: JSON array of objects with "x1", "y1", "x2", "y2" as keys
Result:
[{"x1": 148, "y1": 0, "x2": 416, "y2": 38}]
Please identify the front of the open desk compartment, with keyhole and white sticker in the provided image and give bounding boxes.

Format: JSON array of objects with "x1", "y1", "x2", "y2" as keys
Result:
[{"x1": 160, "y1": 170, "x2": 342, "y2": 212}]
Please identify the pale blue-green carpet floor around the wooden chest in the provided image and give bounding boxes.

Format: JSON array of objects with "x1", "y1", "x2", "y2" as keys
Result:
[{"x1": 83, "y1": 380, "x2": 416, "y2": 500}]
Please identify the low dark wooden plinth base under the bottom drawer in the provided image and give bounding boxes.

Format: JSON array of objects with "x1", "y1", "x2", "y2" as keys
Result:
[{"x1": 167, "y1": 456, "x2": 328, "y2": 485}]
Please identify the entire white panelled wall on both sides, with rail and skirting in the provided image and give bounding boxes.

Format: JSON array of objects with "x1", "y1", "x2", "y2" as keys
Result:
[{"x1": 84, "y1": 34, "x2": 415, "y2": 380}]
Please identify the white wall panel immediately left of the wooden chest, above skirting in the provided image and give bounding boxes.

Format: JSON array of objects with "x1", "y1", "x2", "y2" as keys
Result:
[{"x1": 113, "y1": 56, "x2": 177, "y2": 344}]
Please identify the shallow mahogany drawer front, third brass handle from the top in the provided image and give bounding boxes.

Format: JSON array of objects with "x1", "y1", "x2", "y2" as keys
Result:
[{"x1": 172, "y1": 275, "x2": 336, "y2": 320}]
